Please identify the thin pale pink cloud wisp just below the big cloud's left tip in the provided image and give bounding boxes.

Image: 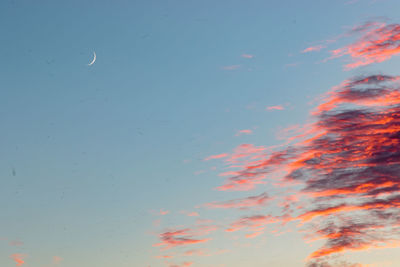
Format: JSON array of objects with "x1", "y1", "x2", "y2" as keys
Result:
[{"x1": 204, "y1": 193, "x2": 271, "y2": 209}]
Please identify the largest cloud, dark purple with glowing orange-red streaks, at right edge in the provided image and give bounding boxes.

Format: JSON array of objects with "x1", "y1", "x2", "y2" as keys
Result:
[{"x1": 209, "y1": 75, "x2": 400, "y2": 266}]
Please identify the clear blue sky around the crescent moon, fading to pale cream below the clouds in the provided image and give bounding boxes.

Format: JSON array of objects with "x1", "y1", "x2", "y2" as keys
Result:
[{"x1": 0, "y1": 0, "x2": 400, "y2": 267}]
